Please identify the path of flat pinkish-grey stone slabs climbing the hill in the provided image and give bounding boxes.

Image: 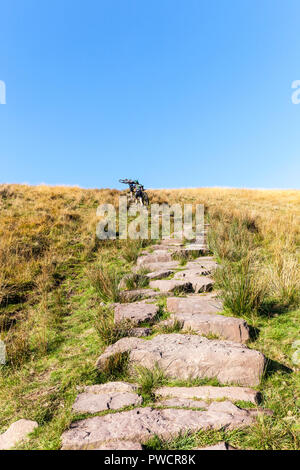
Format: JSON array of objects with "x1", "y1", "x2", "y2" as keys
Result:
[{"x1": 62, "y1": 233, "x2": 268, "y2": 450}]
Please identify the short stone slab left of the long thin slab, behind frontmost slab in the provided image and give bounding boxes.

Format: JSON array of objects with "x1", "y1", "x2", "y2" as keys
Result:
[{"x1": 72, "y1": 382, "x2": 142, "y2": 413}]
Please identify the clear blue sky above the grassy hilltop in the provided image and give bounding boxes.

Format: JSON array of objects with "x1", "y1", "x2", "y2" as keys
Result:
[{"x1": 0, "y1": 0, "x2": 300, "y2": 188}]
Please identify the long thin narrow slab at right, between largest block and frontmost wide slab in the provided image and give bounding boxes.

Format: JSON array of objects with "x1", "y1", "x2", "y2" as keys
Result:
[{"x1": 155, "y1": 385, "x2": 260, "y2": 404}]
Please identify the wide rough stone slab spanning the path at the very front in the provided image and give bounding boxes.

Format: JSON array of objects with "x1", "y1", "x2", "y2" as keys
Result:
[{"x1": 62, "y1": 402, "x2": 255, "y2": 450}]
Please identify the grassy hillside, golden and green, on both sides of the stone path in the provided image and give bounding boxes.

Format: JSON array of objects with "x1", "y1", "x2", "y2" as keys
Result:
[{"x1": 0, "y1": 185, "x2": 300, "y2": 449}]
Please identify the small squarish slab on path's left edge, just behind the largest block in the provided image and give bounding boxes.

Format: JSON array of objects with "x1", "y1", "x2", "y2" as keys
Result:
[{"x1": 114, "y1": 301, "x2": 159, "y2": 325}]
